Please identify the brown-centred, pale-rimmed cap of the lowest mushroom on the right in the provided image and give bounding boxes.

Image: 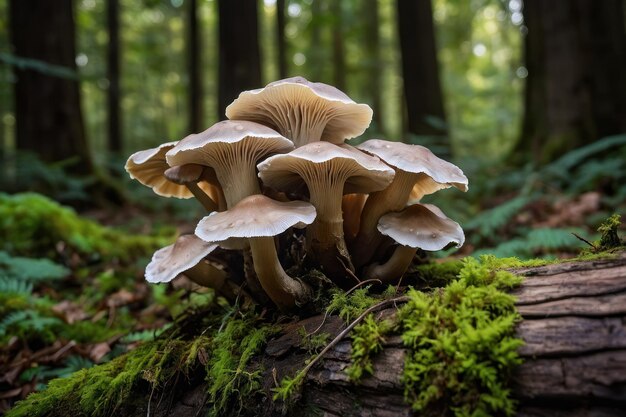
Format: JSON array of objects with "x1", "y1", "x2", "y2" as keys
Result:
[{"x1": 378, "y1": 204, "x2": 465, "y2": 251}]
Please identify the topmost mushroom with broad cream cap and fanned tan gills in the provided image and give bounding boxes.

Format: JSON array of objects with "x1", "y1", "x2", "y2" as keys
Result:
[{"x1": 226, "y1": 77, "x2": 372, "y2": 147}]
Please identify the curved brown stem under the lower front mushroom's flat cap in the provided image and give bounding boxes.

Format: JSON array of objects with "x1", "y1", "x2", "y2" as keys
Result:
[{"x1": 249, "y1": 237, "x2": 312, "y2": 310}]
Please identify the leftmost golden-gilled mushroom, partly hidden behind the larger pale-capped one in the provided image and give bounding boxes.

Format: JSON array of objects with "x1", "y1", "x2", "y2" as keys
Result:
[{"x1": 124, "y1": 142, "x2": 219, "y2": 211}]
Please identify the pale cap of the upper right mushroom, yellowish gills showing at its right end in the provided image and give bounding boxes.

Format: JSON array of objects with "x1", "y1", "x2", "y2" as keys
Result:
[{"x1": 357, "y1": 139, "x2": 468, "y2": 195}]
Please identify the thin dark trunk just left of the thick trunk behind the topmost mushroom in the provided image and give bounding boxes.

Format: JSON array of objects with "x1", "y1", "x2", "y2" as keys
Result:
[{"x1": 187, "y1": 0, "x2": 204, "y2": 133}]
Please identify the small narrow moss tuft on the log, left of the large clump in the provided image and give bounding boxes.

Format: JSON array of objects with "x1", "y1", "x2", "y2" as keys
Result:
[{"x1": 346, "y1": 314, "x2": 393, "y2": 382}]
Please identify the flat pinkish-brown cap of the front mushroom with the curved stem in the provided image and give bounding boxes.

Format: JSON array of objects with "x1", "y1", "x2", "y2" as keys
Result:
[{"x1": 195, "y1": 194, "x2": 316, "y2": 242}]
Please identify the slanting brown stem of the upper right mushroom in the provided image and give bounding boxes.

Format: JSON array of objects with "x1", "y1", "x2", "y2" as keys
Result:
[{"x1": 352, "y1": 168, "x2": 419, "y2": 268}]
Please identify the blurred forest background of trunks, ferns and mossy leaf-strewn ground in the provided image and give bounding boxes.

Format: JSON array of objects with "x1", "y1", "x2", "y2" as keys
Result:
[{"x1": 0, "y1": 0, "x2": 626, "y2": 407}]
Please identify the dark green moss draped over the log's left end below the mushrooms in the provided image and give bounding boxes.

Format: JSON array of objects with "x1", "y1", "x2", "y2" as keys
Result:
[{"x1": 6, "y1": 309, "x2": 275, "y2": 417}]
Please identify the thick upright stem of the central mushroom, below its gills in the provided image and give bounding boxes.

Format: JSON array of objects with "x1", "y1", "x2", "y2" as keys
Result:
[{"x1": 306, "y1": 179, "x2": 354, "y2": 279}]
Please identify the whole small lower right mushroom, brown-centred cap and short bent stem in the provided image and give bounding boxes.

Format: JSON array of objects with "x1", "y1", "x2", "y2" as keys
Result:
[{"x1": 364, "y1": 204, "x2": 465, "y2": 282}]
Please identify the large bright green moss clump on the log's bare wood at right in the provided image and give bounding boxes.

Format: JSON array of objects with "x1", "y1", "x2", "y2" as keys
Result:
[{"x1": 398, "y1": 257, "x2": 522, "y2": 417}]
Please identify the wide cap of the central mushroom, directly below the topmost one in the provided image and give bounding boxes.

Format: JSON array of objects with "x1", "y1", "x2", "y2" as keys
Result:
[{"x1": 257, "y1": 142, "x2": 395, "y2": 194}]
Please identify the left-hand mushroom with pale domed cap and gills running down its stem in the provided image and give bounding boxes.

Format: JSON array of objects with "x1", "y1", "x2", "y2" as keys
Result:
[{"x1": 166, "y1": 120, "x2": 293, "y2": 209}]
